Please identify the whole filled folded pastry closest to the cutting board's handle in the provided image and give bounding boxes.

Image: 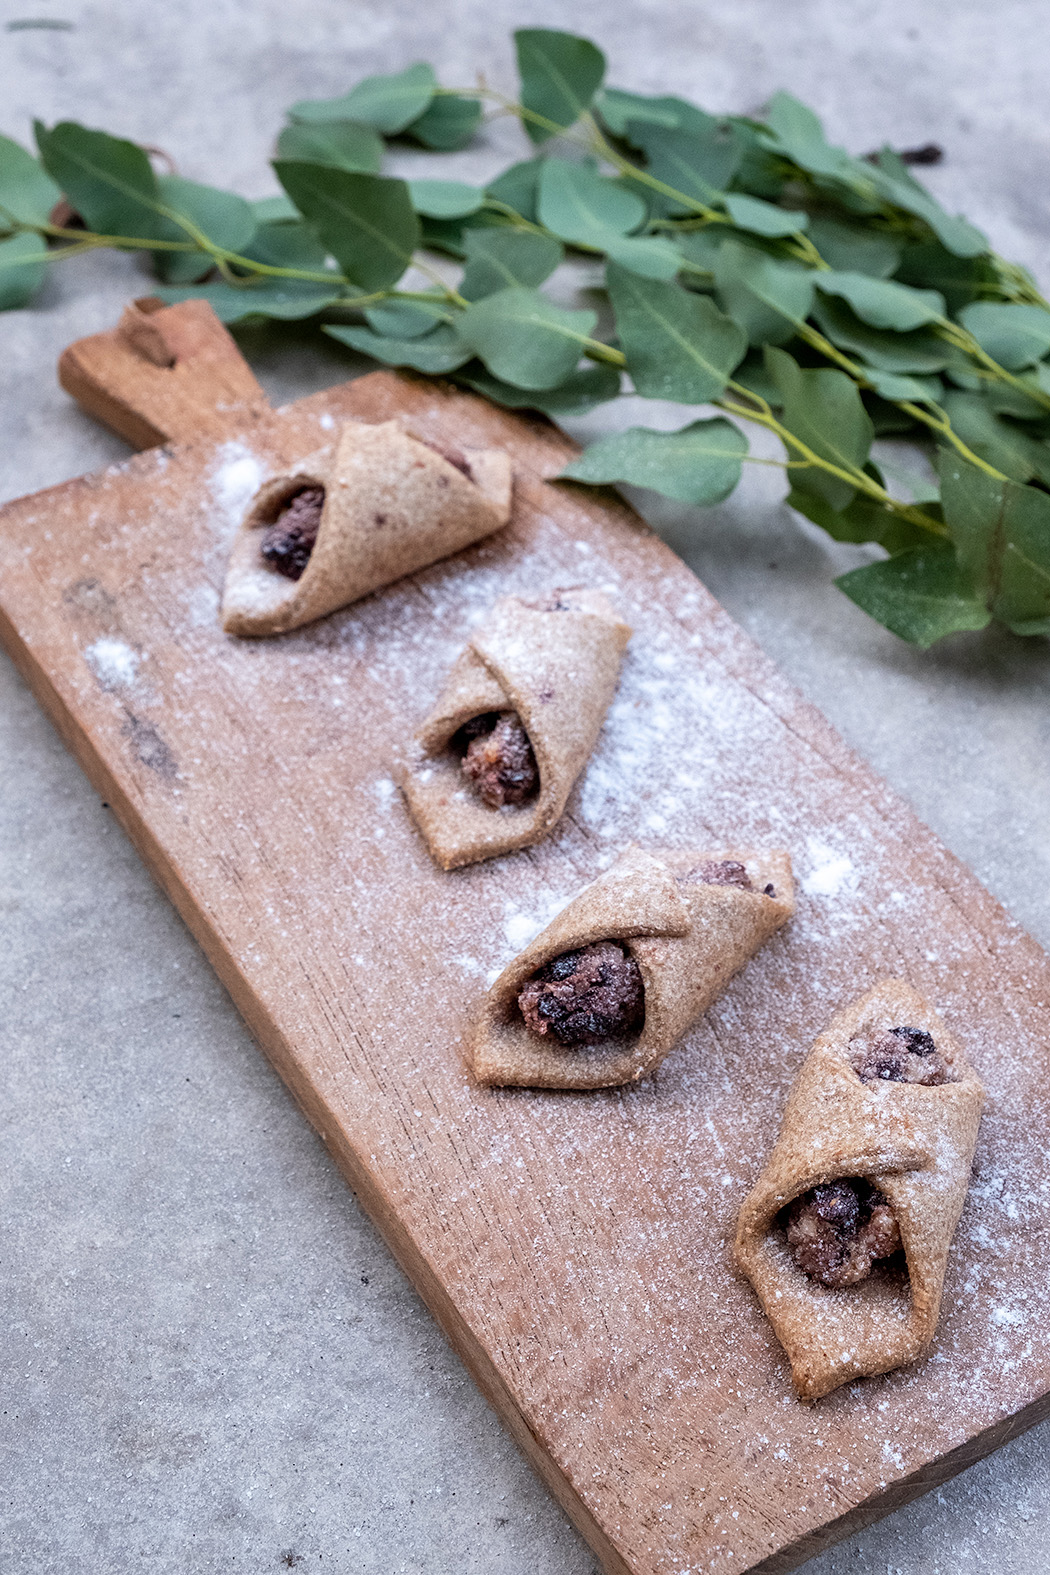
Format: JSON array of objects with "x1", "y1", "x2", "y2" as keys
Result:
[{"x1": 222, "y1": 421, "x2": 512, "y2": 635}]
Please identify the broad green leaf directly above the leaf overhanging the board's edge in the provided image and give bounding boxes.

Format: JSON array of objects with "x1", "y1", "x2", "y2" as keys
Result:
[{"x1": 606, "y1": 263, "x2": 748, "y2": 405}]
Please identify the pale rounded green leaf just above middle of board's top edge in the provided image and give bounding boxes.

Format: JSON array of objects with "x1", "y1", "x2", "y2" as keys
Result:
[{"x1": 458, "y1": 285, "x2": 597, "y2": 389}]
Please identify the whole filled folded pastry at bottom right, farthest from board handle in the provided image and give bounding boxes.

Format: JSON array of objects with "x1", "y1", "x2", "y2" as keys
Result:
[{"x1": 735, "y1": 980, "x2": 984, "y2": 1400}]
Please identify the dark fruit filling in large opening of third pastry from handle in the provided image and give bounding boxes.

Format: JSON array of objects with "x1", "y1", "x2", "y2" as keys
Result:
[{"x1": 518, "y1": 940, "x2": 645, "y2": 1044}]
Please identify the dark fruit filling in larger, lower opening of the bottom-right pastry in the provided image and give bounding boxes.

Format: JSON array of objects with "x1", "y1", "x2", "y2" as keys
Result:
[{"x1": 782, "y1": 1177, "x2": 900, "y2": 1290}]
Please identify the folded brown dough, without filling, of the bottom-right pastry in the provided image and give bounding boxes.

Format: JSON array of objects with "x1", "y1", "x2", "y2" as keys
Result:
[{"x1": 735, "y1": 980, "x2": 984, "y2": 1400}]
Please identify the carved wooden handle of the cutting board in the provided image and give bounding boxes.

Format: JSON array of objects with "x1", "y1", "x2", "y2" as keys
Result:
[{"x1": 58, "y1": 296, "x2": 269, "y2": 449}]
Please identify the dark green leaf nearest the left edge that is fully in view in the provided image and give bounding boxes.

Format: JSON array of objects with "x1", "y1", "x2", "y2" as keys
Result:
[{"x1": 38, "y1": 120, "x2": 164, "y2": 241}]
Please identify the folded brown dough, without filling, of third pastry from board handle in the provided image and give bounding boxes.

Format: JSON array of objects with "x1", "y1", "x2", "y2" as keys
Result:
[{"x1": 469, "y1": 846, "x2": 793, "y2": 1088}]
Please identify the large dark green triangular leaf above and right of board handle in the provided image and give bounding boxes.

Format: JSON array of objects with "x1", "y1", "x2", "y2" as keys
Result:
[{"x1": 274, "y1": 159, "x2": 420, "y2": 290}]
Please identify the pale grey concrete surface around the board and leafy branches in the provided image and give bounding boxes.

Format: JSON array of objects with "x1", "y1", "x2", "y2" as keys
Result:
[{"x1": 0, "y1": 0, "x2": 1050, "y2": 1575}]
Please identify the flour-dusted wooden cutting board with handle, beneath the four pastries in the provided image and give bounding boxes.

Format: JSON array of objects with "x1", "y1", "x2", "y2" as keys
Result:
[{"x1": 0, "y1": 304, "x2": 1050, "y2": 1575}]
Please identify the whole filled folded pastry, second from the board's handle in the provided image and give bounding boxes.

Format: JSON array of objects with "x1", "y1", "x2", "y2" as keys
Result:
[{"x1": 398, "y1": 589, "x2": 631, "y2": 869}]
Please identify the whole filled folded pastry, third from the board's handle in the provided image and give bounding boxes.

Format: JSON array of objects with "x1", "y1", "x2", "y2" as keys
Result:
[{"x1": 469, "y1": 846, "x2": 793, "y2": 1088}]
